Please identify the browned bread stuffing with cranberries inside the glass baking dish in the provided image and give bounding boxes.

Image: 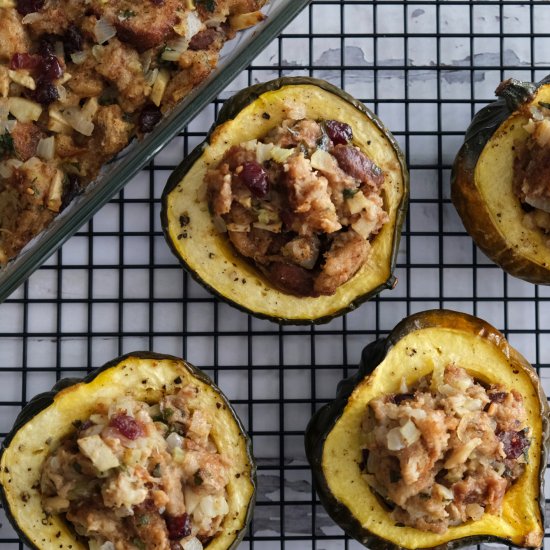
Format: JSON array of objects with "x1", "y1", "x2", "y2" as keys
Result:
[{"x1": 0, "y1": 0, "x2": 265, "y2": 266}]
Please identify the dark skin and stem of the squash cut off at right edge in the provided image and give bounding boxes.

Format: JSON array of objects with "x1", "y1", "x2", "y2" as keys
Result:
[{"x1": 451, "y1": 75, "x2": 550, "y2": 284}]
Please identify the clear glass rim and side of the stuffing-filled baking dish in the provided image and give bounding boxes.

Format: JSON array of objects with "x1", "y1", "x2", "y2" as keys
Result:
[{"x1": 0, "y1": 0, "x2": 311, "y2": 302}]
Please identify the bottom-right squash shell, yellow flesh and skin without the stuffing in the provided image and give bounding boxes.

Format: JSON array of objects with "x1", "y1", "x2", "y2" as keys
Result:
[{"x1": 305, "y1": 310, "x2": 549, "y2": 550}]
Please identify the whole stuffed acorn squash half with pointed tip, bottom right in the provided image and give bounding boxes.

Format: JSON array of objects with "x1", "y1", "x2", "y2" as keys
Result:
[{"x1": 305, "y1": 310, "x2": 549, "y2": 550}]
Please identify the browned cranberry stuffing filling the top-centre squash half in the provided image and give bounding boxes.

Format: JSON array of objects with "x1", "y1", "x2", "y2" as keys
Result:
[{"x1": 206, "y1": 119, "x2": 389, "y2": 296}]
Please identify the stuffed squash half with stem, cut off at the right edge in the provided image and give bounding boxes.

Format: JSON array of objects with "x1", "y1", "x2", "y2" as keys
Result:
[{"x1": 451, "y1": 79, "x2": 550, "y2": 284}]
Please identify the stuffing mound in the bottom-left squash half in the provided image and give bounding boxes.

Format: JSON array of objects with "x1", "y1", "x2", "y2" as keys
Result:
[{"x1": 40, "y1": 385, "x2": 231, "y2": 550}]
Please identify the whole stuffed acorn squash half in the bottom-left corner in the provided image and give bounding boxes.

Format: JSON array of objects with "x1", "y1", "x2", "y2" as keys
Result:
[{"x1": 0, "y1": 352, "x2": 255, "y2": 550}]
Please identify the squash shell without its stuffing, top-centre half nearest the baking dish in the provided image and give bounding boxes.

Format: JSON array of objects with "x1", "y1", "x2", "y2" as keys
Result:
[{"x1": 161, "y1": 77, "x2": 409, "y2": 324}]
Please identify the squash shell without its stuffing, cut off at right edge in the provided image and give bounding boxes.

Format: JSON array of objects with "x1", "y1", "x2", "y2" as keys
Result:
[{"x1": 451, "y1": 79, "x2": 550, "y2": 284}]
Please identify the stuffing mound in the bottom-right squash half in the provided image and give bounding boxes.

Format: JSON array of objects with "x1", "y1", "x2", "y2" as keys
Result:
[{"x1": 360, "y1": 365, "x2": 531, "y2": 533}]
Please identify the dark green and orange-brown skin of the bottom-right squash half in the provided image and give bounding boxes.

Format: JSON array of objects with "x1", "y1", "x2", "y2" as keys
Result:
[{"x1": 305, "y1": 310, "x2": 550, "y2": 550}]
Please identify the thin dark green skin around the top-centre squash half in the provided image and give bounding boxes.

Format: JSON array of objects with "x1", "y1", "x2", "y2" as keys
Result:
[{"x1": 160, "y1": 76, "x2": 409, "y2": 325}]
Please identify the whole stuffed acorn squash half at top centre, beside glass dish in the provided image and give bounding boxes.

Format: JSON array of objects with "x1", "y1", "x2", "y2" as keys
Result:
[{"x1": 161, "y1": 77, "x2": 409, "y2": 324}]
